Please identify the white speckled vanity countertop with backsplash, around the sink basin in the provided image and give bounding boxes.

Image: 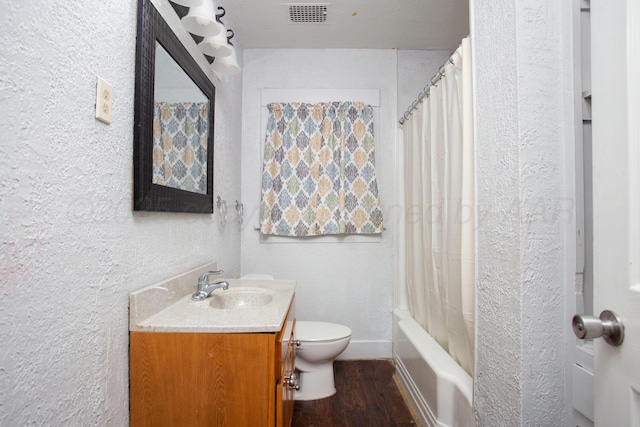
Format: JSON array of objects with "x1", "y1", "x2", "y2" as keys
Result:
[{"x1": 129, "y1": 265, "x2": 295, "y2": 333}]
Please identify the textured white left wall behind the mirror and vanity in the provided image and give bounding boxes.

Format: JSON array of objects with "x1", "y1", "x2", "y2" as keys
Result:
[{"x1": 0, "y1": 0, "x2": 242, "y2": 426}]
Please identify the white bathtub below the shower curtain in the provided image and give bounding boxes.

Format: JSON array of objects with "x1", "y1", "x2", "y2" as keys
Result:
[{"x1": 393, "y1": 309, "x2": 475, "y2": 427}]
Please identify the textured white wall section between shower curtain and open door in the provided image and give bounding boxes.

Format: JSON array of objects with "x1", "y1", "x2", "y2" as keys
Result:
[{"x1": 471, "y1": 0, "x2": 575, "y2": 426}]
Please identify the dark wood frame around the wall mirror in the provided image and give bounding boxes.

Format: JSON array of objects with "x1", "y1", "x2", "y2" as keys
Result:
[{"x1": 133, "y1": 0, "x2": 215, "y2": 213}]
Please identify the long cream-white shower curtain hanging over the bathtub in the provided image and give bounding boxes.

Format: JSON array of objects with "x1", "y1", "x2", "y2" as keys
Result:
[{"x1": 401, "y1": 37, "x2": 475, "y2": 374}]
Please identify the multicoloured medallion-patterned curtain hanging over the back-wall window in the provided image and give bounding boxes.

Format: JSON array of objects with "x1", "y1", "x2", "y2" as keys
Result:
[{"x1": 260, "y1": 102, "x2": 383, "y2": 236}]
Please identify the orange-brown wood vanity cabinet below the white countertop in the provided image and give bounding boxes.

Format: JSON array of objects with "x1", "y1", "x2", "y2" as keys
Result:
[{"x1": 130, "y1": 302, "x2": 295, "y2": 427}]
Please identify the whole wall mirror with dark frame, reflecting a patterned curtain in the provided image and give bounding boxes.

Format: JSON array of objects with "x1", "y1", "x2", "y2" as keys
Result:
[{"x1": 133, "y1": 0, "x2": 215, "y2": 213}]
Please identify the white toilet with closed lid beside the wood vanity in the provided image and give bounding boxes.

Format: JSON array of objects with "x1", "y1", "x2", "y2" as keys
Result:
[{"x1": 294, "y1": 321, "x2": 351, "y2": 400}]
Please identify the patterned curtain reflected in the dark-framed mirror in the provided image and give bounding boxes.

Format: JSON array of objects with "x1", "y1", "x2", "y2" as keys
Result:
[{"x1": 152, "y1": 102, "x2": 209, "y2": 194}]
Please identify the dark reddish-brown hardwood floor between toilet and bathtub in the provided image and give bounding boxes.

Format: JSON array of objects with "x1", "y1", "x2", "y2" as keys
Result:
[{"x1": 292, "y1": 360, "x2": 416, "y2": 427}]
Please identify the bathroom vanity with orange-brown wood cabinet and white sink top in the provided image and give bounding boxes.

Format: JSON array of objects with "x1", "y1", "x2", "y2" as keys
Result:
[{"x1": 130, "y1": 266, "x2": 296, "y2": 427}]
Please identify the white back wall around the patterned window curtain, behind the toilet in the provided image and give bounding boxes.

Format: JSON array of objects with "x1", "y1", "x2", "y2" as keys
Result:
[{"x1": 242, "y1": 49, "x2": 396, "y2": 357}]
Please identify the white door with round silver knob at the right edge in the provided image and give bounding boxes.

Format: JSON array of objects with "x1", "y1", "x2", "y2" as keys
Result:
[{"x1": 591, "y1": 0, "x2": 640, "y2": 427}]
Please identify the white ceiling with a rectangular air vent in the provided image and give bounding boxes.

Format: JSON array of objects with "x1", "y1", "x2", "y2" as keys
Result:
[{"x1": 216, "y1": 0, "x2": 469, "y2": 51}]
